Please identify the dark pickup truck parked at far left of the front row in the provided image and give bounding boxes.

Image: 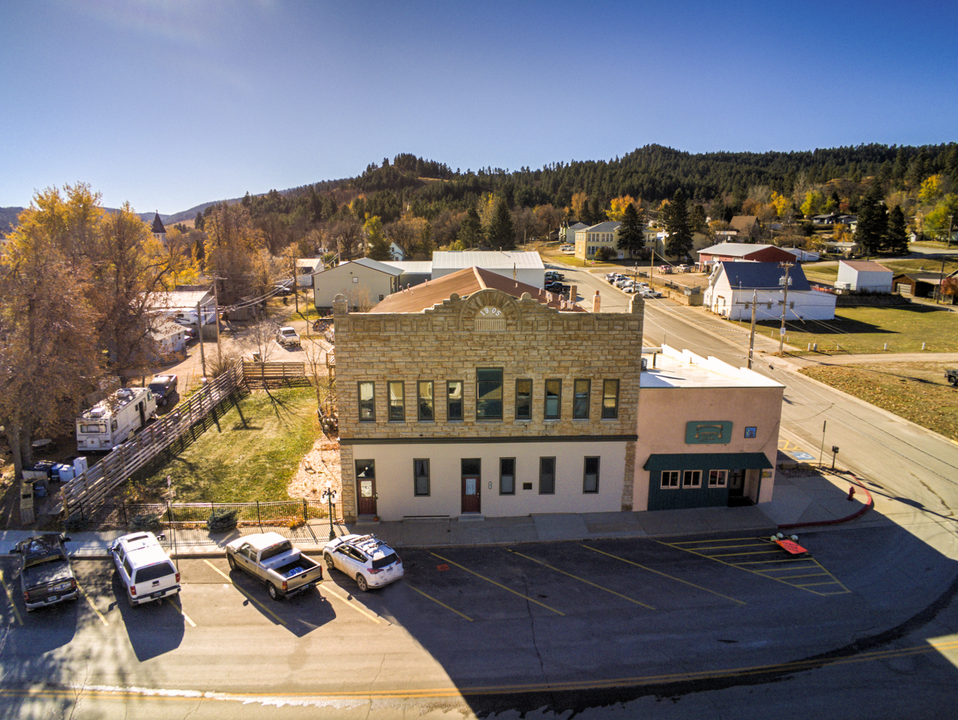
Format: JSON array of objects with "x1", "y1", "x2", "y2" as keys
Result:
[{"x1": 13, "y1": 533, "x2": 80, "y2": 611}]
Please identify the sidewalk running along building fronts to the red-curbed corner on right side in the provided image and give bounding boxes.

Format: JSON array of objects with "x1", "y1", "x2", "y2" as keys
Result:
[{"x1": 0, "y1": 471, "x2": 885, "y2": 558}]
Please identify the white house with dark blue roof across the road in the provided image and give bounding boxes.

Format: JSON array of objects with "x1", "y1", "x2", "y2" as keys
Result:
[{"x1": 703, "y1": 262, "x2": 836, "y2": 320}]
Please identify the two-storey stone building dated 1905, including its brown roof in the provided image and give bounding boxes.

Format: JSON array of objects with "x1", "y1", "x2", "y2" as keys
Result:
[{"x1": 333, "y1": 268, "x2": 644, "y2": 520}]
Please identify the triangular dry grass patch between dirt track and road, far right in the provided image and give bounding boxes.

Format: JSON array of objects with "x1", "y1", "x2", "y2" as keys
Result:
[{"x1": 802, "y1": 362, "x2": 958, "y2": 441}]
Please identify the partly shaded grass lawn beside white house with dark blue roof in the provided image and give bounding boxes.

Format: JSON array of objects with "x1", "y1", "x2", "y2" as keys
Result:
[{"x1": 739, "y1": 304, "x2": 958, "y2": 355}]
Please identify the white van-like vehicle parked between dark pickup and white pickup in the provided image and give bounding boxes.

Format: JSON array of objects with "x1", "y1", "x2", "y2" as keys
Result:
[{"x1": 110, "y1": 532, "x2": 180, "y2": 607}]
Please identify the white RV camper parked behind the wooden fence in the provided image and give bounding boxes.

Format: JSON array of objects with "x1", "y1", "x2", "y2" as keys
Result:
[{"x1": 77, "y1": 388, "x2": 156, "y2": 452}]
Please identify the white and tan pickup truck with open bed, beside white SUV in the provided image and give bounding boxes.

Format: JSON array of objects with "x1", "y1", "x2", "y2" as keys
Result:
[{"x1": 226, "y1": 532, "x2": 323, "y2": 600}]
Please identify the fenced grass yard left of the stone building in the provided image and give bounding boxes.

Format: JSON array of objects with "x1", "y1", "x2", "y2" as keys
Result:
[{"x1": 135, "y1": 388, "x2": 321, "y2": 502}]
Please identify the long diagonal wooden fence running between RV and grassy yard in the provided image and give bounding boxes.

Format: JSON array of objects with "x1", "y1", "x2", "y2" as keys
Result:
[{"x1": 60, "y1": 366, "x2": 243, "y2": 517}]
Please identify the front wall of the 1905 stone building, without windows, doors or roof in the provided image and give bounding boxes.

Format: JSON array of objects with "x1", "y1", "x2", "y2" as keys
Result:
[{"x1": 333, "y1": 288, "x2": 644, "y2": 519}]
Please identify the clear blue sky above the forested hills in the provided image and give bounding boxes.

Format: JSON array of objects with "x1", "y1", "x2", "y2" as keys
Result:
[{"x1": 0, "y1": 0, "x2": 958, "y2": 214}]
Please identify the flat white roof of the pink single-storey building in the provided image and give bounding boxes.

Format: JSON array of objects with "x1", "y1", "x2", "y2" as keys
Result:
[{"x1": 639, "y1": 345, "x2": 785, "y2": 388}]
